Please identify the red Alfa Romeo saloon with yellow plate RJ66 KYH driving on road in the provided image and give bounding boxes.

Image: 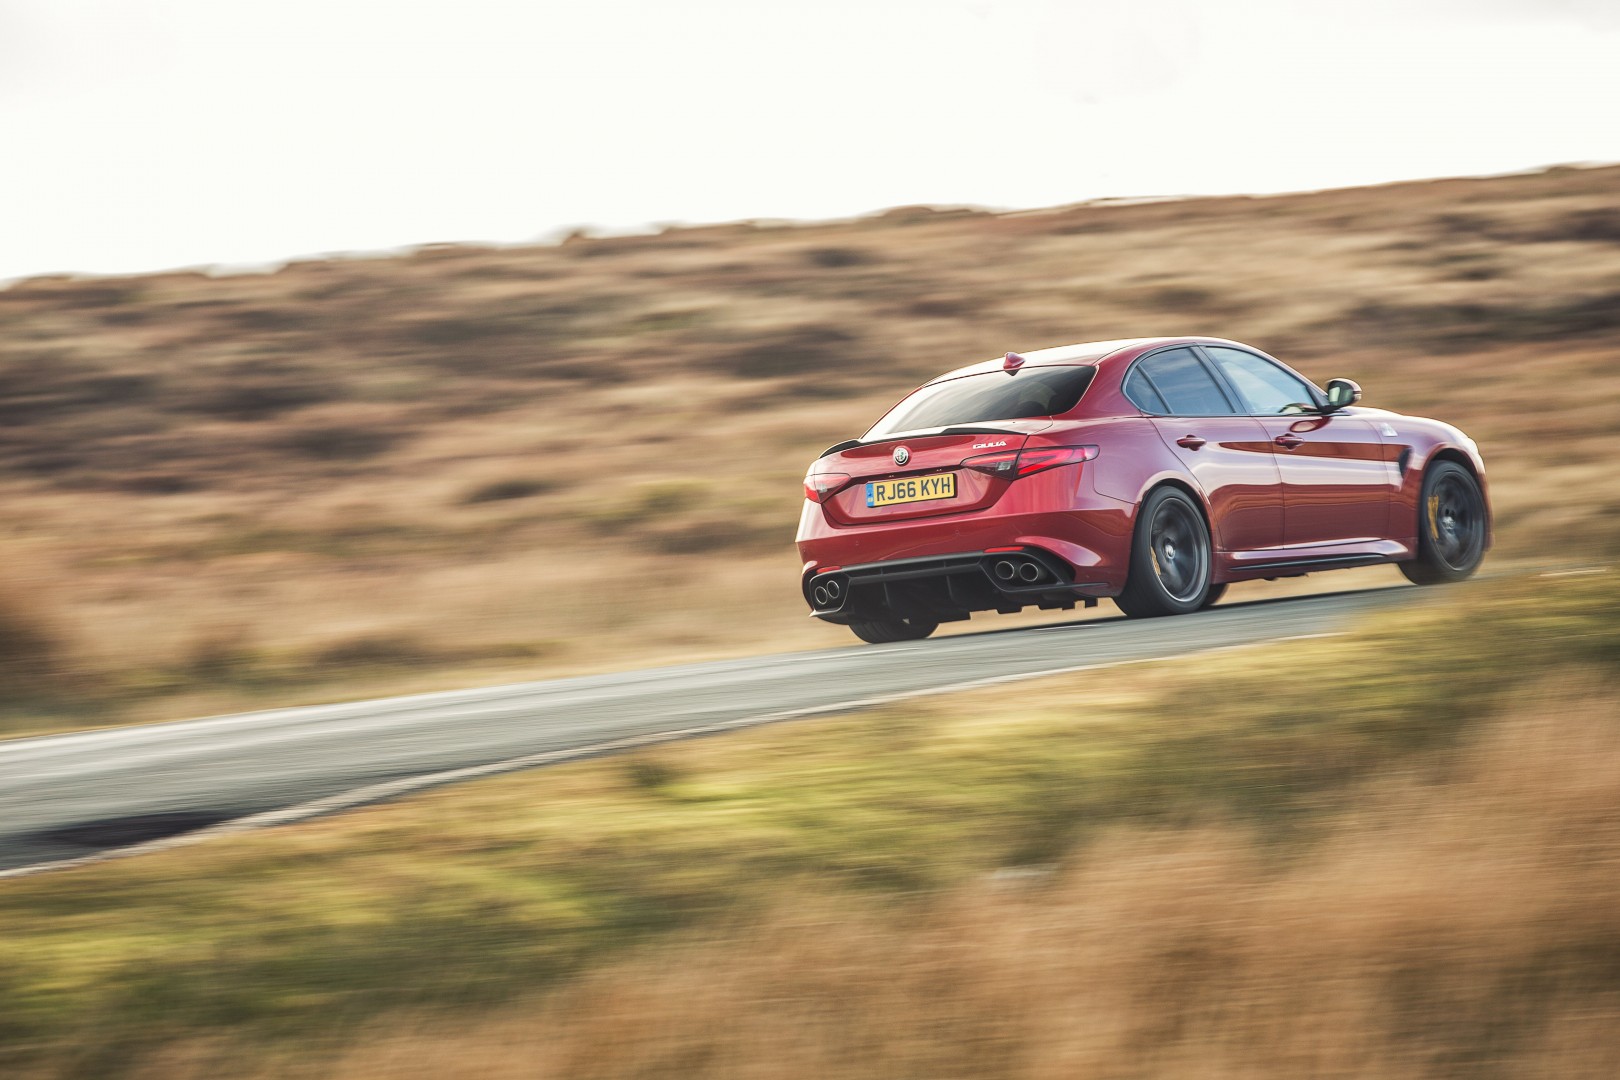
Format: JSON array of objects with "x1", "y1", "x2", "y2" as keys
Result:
[{"x1": 799, "y1": 337, "x2": 1490, "y2": 641}]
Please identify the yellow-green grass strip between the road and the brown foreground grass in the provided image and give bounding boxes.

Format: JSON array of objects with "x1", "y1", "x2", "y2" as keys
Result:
[{"x1": 0, "y1": 576, "x2": 1620, "y2": 1077}]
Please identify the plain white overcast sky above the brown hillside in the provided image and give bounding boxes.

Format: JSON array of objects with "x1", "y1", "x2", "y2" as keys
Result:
[{"x1": 0, "y1": 0, "x2": 1620, "y2": 280}]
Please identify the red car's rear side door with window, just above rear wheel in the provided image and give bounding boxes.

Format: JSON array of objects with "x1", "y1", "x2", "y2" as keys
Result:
[{"x1": 1123, "y1": 345, "x2": 1283, "y2": 551}]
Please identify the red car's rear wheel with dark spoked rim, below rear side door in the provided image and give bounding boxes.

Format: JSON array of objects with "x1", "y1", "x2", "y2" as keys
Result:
[{"x1": 1115, "y1": 487, "x2": 1213, "y2": 619}]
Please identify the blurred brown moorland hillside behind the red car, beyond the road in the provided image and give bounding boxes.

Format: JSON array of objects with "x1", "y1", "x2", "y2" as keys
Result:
[{"x1": 0, "y1": 167, "x2": 1620, "y2": 732}]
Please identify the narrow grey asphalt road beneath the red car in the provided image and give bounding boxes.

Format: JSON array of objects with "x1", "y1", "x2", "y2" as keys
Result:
[{"x1": 0, "y1": 588, "x2": 1413, "y2": 871}]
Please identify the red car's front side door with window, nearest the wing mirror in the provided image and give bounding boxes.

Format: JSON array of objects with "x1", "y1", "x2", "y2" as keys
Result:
[{"x1": 1202, "y1": 345, "x2": 1400, "y2": 547}]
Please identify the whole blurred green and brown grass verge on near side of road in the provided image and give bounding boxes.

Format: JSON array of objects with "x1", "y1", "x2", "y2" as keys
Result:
[{"x1": 0, "y1": 576, "x2": 1620, "y2": 1077}]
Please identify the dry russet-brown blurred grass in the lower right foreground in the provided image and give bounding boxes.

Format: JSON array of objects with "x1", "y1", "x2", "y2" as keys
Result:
[{"x1": 196, "y1": 683, "x2": 1620, "y2": 1080}]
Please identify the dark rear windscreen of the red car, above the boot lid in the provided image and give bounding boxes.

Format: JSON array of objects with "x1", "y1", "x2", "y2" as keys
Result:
[{"x1": 863, "y1": 368, "x2": 1097, "y2": 439}]
